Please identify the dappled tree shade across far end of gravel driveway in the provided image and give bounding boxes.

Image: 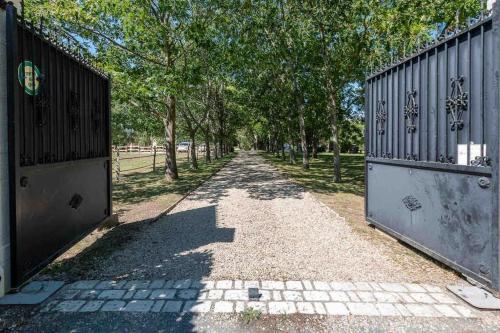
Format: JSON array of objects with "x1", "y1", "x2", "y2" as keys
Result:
[{"x1": 191, "y1": 153, "x2": 304, "y2": 204}]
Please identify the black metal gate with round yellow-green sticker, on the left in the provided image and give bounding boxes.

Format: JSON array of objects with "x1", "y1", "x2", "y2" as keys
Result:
[{"x1": 6, "y1": 5, "x2": 112, "y2": 286}]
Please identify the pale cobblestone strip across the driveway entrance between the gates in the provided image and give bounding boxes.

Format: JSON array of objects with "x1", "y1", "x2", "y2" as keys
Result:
[{"x1": 41, "y1": 279, "x2": 477, "y2": 318}]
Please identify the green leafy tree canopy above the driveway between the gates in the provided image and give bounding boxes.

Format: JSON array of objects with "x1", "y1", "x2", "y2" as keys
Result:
[{"x1": 26, "y1": 0, "x2": 482, "y2": 181}]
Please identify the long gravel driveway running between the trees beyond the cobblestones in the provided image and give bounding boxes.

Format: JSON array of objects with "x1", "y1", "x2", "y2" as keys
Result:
[{"x1": 88, "y1": 153, "x2": 457, "y2": 285}]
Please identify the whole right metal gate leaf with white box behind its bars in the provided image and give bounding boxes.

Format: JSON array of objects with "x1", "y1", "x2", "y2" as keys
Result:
[{"x1": 366, "y1": 6, "x2": 500, "y2": 290}]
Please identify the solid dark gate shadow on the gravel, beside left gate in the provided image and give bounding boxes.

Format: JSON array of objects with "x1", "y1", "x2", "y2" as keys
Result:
[{"x1": 44, "y1": 205, "x2": 235, "y2": 281}]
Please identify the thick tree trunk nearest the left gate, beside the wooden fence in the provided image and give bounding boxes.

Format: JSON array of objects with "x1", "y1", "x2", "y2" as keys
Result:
[{"x1": 163, "y1": 95, "x2": 179, "y2": 180}]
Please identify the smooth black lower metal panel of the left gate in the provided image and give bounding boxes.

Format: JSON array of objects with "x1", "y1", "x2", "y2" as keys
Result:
[{"x1": 16, "y1": 158, "x2": 109, "y2": 281}]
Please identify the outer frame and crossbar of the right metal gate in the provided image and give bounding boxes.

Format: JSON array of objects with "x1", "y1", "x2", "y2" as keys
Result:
[{"x1": 364, "y1": 3, "x2": 500, "y2": 297}]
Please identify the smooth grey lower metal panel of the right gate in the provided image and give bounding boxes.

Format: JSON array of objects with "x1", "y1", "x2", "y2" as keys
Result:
[{"x1": 368, "y1": 162, "x2": 493, "y2": 283}]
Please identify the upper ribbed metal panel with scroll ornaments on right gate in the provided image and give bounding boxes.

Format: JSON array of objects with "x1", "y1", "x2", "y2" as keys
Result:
[{"x1": 366, "y1": 18, "x2": 494, "y2": 165}]
